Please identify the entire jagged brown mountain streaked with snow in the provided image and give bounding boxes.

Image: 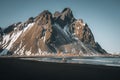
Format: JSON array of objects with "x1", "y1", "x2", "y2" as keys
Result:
[{"x1": 0, "y1": 8, "x2": 107, "y2": 55}]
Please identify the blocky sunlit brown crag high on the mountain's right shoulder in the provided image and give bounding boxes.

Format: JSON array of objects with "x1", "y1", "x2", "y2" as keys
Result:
[{"x1": 71, "y1": 19, "x2": 95, "y2": 45}]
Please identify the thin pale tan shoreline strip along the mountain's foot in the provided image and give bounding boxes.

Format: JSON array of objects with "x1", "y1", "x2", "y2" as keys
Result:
[{"x1": 0, "y1": 53, "x2": 120, "y2": 58}]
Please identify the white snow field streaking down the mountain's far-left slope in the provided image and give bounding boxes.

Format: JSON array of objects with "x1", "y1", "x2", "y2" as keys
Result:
[{"x1": 0, "y1": 23, "x2": 34, "y2": 55}]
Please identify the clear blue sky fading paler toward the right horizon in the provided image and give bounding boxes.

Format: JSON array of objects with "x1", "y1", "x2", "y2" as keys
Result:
[{"x1": 0, "y1": 0, "x2": 120, "y2": 53}]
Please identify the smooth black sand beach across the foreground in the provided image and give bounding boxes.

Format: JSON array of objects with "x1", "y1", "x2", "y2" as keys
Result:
[{"x1": 0, "y1": 58, "x2": 120, "y2": 80}]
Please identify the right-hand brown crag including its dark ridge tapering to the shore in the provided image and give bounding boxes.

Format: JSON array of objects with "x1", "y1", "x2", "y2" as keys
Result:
[{"x1": 70, "y1": 19, "x2": 107, "y2": 53}]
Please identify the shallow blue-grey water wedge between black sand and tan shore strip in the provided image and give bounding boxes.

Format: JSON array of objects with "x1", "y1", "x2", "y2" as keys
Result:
[{"x1": 22, "y1": 57, "x2": 120, "y2": 67}]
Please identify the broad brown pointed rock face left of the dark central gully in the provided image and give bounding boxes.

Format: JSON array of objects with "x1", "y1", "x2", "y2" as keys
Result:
[{"x1": 11, "y1": 11, "x2": 53, "y2": 54}]
